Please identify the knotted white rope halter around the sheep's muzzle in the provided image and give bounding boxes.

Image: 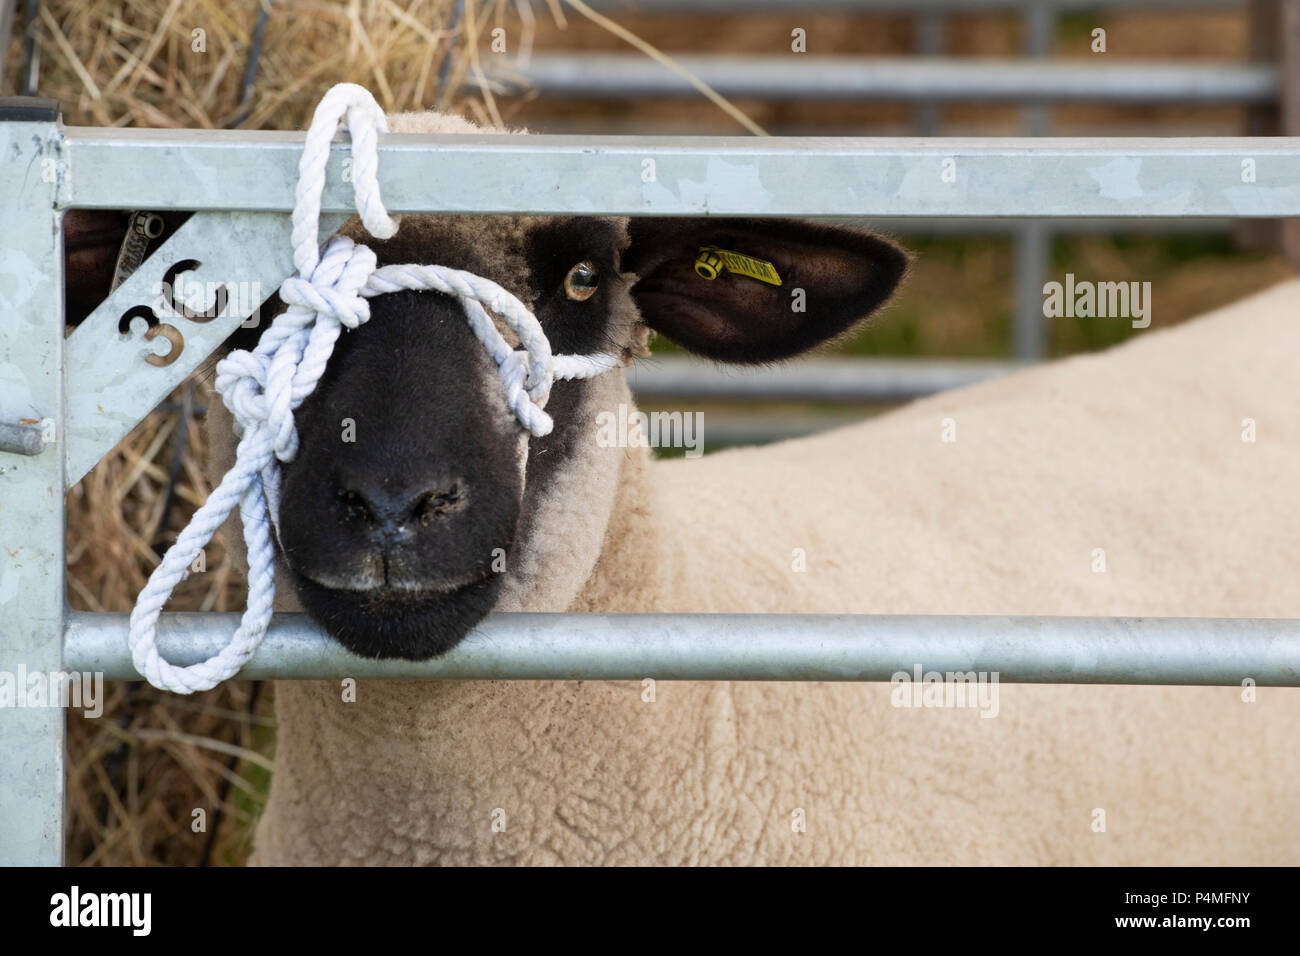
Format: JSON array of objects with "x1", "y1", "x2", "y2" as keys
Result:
[{"x1": 126, "y1": 83, "x2": 619, "y2": 693}]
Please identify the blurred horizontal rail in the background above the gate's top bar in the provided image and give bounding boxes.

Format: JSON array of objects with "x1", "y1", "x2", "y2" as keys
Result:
[{"x1": 486, "y1": 52, "x2": 1278, "y2": 105}]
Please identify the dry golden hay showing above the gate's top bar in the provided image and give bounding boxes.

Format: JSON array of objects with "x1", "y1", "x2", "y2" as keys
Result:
[{"x1": 4, "y1": 0, "x2": 480, "y2": 130}]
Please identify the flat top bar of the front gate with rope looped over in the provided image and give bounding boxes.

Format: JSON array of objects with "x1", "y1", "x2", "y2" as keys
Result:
[{"x1": 60, "y1": 127, "x2": 1300, "y2": 219}]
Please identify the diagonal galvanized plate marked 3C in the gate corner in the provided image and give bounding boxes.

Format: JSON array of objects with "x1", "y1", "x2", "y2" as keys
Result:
[{"x1": 65, "y1": 213, "x2": 346, "y2": 488}]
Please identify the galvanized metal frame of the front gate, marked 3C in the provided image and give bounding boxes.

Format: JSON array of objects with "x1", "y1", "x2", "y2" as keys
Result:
[{"x1": 0, "y1": 100, "x2": 1300, "y2": 864}]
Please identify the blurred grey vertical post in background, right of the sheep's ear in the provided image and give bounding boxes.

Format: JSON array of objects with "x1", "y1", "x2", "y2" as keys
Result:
[{"x1": 1013, "y1": 3, "x2": 1056, "y2": 359}]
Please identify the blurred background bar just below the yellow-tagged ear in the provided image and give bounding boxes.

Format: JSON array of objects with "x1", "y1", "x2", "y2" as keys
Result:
[{"x1": 628, "y1": 355, "x2": 1024, "y2": 402}]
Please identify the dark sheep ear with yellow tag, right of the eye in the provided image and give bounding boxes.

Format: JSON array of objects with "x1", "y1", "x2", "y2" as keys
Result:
[{"x1": 623, "y1": 219, "x2": 907, "y2": 363}]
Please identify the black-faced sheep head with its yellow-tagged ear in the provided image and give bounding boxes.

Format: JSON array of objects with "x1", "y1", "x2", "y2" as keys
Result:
[{"x1": 266, "y1": 216, "x2": 907, "y2": 659}]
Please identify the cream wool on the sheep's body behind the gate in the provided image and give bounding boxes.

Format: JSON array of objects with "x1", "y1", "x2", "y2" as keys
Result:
[{"x1": 209, "y1": 108, "x2": 1300, "y2": 865}]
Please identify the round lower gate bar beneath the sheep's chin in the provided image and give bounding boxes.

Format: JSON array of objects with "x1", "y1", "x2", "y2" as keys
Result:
[{"x1": 65, "y1": 611, "x2": 1300, "y2": 687}]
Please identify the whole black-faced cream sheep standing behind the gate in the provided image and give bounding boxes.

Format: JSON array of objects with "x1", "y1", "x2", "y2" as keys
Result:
[{"x1": 192, "y1": 114, "x2": 1300, "y2": 865}]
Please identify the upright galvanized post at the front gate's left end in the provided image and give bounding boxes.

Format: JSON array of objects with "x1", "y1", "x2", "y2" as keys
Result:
[{"x1": 0, "y1": 99, "x2": 66, "y2": 865}]
